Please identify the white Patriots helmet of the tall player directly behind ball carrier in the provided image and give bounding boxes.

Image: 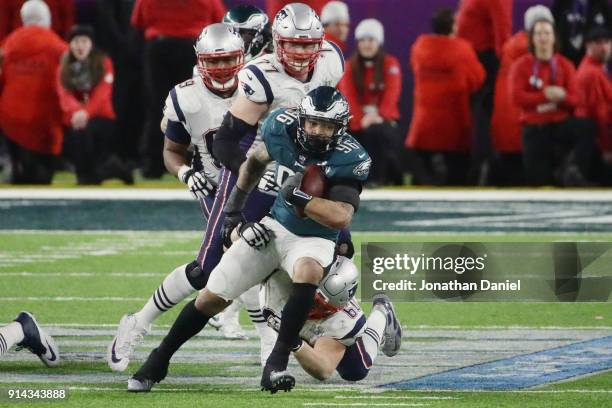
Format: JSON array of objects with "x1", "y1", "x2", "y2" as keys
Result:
[{"x1": 272, "y1": 3, "x2": 325, "y2": 75}]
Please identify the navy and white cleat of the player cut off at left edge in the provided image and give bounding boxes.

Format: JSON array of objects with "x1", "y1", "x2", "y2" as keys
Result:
[{"x1": 15, "y1": 312, "x2": 60, "y2": 367}]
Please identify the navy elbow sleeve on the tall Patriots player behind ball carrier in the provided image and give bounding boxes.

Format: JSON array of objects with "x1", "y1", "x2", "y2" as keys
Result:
[{"x1": 212, "y1": 112, "x2": 257, "y2": 174}]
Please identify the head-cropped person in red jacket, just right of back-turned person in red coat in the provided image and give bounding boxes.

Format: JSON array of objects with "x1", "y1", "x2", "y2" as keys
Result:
[{"x1": 457, "y1": 0, "x2": 513, "y2": 182}]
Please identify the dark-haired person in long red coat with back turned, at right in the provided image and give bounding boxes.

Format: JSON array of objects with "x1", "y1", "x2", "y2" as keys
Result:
[{"x1": 406, "y1": 9, "x2": 485, "y2": 185}]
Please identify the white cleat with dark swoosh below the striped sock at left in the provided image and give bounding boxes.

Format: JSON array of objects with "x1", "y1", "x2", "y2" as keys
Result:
[{"x1": 106, "y1": 314, "x2": 151, "y2": 371}]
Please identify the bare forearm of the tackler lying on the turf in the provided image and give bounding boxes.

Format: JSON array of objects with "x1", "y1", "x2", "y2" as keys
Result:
[{"x1": 293, "y1": 337, "x2": 346, "y2": 381}]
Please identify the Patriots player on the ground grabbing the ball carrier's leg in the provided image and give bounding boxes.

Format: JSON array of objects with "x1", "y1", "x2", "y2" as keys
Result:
[{"x1": 260, "y1": 257, "x2": 401, "y2": 381}]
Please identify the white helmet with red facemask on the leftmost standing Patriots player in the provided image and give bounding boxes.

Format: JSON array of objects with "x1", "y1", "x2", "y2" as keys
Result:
[{"x1": 194, "y1": 23, "x2": 244, "y2": 92}]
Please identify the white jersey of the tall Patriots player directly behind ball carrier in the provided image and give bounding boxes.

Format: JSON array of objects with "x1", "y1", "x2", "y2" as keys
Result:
[{"x1": 238, "y1": 41, "x2": 344, "y2": 134}]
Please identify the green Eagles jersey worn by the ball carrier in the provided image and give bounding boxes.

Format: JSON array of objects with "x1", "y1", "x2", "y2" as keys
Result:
[{"x1": 261, "y1": 109, "x2": 372, "y2": 241}]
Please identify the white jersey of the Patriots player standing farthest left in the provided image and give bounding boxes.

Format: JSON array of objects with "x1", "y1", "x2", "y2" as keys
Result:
[{"x1": 164, "y1": 76, "x2": 238, "y2": 181}]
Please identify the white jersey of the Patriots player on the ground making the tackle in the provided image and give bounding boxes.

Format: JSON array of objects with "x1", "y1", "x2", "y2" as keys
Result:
[{"x1": 259, "y1": 257, "x2": 366, "y2": 347}]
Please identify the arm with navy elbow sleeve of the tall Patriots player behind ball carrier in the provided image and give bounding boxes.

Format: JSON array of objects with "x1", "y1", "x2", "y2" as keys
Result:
[{"x1": 212, "y1": 95, "x2": 269, "y2": 174}]
